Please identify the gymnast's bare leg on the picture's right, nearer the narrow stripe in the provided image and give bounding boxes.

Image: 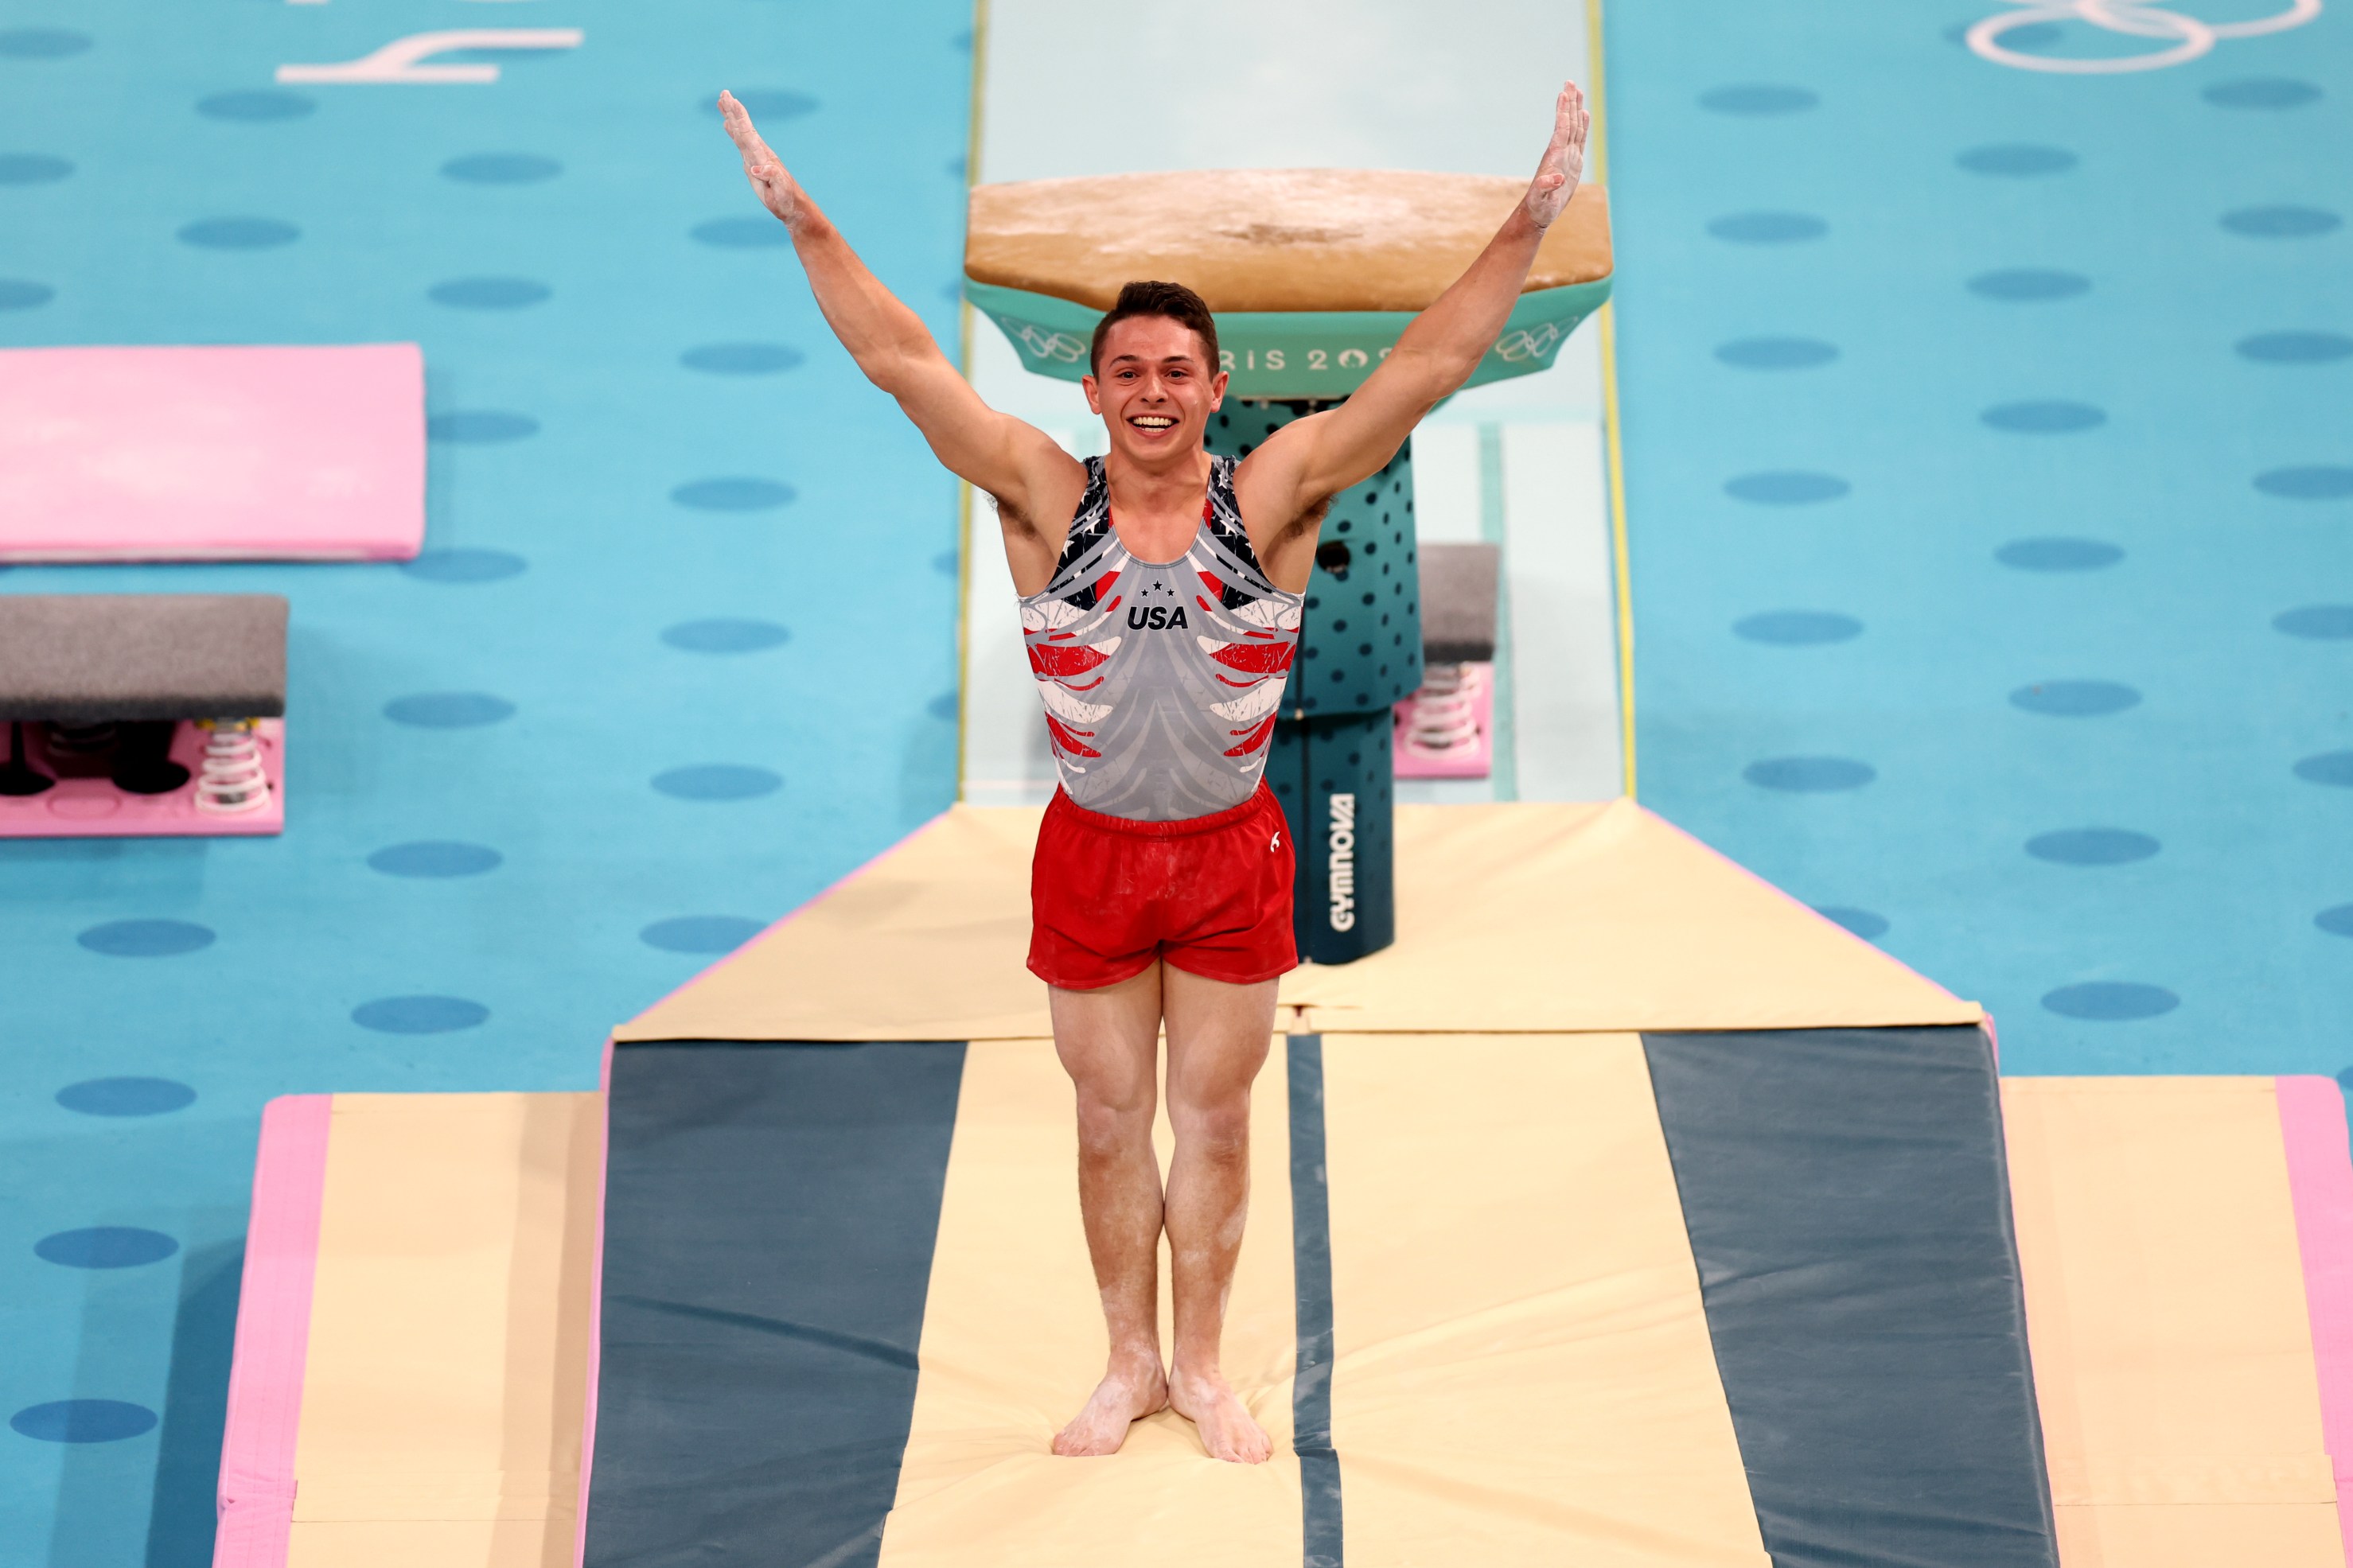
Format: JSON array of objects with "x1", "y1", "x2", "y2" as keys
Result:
[{"x1": 1160, "y1": 964, "x2": 1276, "y2": 1465}]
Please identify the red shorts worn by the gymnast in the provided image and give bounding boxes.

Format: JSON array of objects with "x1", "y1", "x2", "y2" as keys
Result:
[{"x1": 1030, "y1": 783, "x2": 1299, "y2": 990}]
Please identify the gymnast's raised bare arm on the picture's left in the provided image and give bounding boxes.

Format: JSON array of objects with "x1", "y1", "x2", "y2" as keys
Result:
[{"x1": 720, "y1": 91, "x2": 1087, "y2": 540}]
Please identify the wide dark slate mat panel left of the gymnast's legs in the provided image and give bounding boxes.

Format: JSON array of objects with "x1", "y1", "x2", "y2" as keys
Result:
[{"x1": 588, "y1": 1041, "x2": 964, "y2": 1568}]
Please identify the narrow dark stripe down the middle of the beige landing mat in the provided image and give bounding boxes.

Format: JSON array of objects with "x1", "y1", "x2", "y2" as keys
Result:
[{"x1": 1287, "y1": 1034, "x2": 1343, "y2": 1568}]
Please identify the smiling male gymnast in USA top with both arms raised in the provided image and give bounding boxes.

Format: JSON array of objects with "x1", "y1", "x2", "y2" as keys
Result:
[{"x1": 720, "y1": 84, "x2": 1586, "y2": 1465}]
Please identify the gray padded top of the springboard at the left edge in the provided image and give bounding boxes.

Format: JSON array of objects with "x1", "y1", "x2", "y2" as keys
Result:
[{"x1": 0, "y1": 593, "x2": 287, "y2": 724}]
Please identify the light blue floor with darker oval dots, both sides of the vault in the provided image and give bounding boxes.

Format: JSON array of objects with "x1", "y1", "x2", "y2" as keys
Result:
[{"x1": 0, "y1": 0, "x2": 2353, "y2": 1568}]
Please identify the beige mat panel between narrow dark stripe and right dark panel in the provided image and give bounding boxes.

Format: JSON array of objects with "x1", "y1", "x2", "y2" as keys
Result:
[{"x1": 1323, "y1": 1034, "x2": 1767, "y2": 1568}]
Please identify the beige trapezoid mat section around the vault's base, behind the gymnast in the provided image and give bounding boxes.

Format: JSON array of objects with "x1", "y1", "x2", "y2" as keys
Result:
[{"x1": 617, "y1": 802, "x2": 1984, "y2": 1041}]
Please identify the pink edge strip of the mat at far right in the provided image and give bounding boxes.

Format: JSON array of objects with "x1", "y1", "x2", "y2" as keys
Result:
[{"x1": 2277, "y1": 1076, "x2": 2353, "y2": 1561}]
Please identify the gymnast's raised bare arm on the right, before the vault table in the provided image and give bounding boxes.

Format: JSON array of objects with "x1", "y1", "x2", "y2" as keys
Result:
[{"x1": 1235, "y1": 82, "x2": 1588, "y2": 583}]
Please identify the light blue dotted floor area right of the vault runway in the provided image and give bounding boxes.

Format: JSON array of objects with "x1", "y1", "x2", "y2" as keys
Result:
[{"x1": 1607, "y1": 0, "x2": 2353, "y2": 1072}]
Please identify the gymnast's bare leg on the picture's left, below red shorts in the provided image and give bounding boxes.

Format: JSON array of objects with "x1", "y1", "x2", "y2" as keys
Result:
[{"x1": 1047, "y1": 959, "x2": 1171, "y2": 1455}]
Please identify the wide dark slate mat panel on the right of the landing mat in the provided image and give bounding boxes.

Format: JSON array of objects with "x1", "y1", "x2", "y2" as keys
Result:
[{"x1": 1642, "y1": 1027, "x2": 2059, "y2": 1568}]
